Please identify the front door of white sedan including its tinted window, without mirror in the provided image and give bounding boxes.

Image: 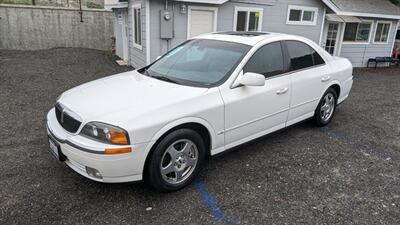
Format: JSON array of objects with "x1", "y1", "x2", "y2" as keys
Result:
[{"x1": 221, "y1": 42, "x2": 291, "y2": 148}]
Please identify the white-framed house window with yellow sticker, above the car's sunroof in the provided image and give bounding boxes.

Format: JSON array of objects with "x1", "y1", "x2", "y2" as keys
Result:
[{"x1": 233, "y1": 7, "x2": 263, "y2": 31}]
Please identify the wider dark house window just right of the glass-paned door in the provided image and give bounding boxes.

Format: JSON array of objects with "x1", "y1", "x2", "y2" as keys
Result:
[{"x1": 343, "y1": 22, "x2": 372, "y2": 43}]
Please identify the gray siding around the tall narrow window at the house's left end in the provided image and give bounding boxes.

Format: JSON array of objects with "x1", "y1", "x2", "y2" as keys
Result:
[{"x1": 128, "y1": 0, "x2": 147, "y2": 68}]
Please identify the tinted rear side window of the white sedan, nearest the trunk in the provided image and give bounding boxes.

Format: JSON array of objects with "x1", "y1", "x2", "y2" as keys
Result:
[{"x1": 286, "y1": 41, "x2": 325, "y2": 71}]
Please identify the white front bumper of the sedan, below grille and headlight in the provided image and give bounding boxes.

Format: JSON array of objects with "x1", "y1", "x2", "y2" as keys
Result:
[{"x1": 47, "y1": 108, "x2": 152, "y2": 183}]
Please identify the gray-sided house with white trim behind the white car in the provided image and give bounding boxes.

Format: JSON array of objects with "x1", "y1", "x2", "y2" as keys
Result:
[{"x1": 105, "y1": 0, "x2": 400, "y2": 68}]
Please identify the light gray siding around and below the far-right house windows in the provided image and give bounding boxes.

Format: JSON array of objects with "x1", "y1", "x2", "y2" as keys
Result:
[{"x1": 340, "y1": 18, "x2": 397, "y2": 67}]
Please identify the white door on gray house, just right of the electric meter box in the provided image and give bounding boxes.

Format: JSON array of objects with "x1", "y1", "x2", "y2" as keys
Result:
[{"x1": 188, "y1": 7, "x2": 217, "y2": 38}]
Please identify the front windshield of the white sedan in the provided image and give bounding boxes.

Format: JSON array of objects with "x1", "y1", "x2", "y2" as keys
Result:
[{"x1": 139, "y1": 39, "x2": 250, "y2": 87}]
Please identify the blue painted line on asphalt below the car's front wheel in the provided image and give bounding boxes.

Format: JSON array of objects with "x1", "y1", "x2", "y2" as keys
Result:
[{"x1": 195, "y1": 180, "x2": 230, "y2": 225}]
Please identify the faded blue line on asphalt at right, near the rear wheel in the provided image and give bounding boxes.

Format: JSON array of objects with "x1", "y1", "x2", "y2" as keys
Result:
[{"x1": 321, "y1": 127, "x2": 400, "y2": 160}]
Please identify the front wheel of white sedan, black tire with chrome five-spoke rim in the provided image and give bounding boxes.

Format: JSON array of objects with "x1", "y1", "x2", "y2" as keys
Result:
[{"x1": 145, "y1": 129, "x2": 207, "y2": 192}]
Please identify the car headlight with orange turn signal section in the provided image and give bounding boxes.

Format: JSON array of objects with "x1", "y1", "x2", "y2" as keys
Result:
[{"x1": 80, "y1": 122, "x2": 129, "y2": 145}]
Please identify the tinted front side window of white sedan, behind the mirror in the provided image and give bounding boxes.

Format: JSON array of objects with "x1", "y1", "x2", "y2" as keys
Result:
[{"x1": 243, "y1": 42, "x2": 284, "y2": 78}]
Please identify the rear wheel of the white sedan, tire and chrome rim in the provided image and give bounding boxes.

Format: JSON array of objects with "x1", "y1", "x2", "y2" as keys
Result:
[{"x1": 314, "y1": 88, "x2": 337, "y2": 127}]
